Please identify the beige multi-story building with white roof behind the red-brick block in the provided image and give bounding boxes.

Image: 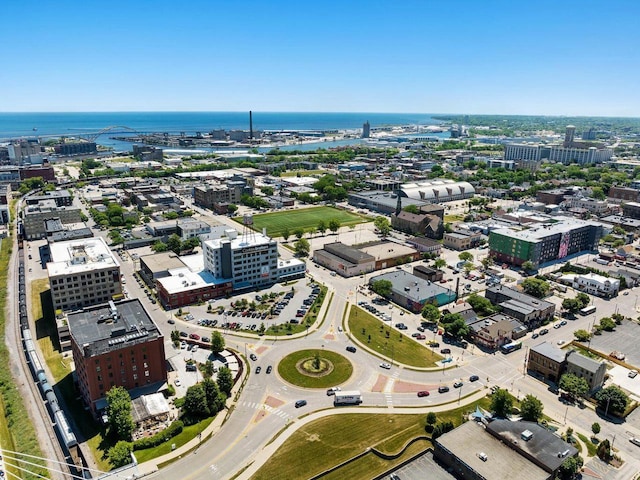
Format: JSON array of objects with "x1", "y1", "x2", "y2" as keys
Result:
[{"x1": 47, "y1": 237, "x2": 122, "y2": 314}]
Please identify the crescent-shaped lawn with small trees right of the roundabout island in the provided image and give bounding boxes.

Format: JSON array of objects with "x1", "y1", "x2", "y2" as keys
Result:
[{"x1": 347, "y1": 306, "x2": 442, "y2": 367}]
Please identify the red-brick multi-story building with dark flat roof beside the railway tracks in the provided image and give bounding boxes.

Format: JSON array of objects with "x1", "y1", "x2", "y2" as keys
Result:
[{"x1": 65, "y1": 300, "x2": 167, "y2": 417}]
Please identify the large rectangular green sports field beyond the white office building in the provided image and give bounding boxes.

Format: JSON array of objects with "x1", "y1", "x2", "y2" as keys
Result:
[{"x1": 234, "y1": 207, "x2": 369, "y2": 238}]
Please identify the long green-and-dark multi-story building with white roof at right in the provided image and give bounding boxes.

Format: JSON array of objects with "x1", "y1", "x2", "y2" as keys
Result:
[{"x1": 489, "y1": 219, "x2": 602, "y2": 266}]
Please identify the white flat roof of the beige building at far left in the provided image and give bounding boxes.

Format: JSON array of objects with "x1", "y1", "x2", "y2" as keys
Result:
[{"x1": 47, "y1": 237, "x2": 120, "y2": 277}]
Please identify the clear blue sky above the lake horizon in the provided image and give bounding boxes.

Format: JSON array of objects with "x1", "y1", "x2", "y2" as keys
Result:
[{"x1": 0, "y1": 0, "x2": 640, "y2": 116}]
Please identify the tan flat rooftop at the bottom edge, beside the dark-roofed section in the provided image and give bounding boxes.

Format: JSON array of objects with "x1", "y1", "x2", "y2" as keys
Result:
[{"x1": 436, "y1": 421, "x2": 549, "y2": 480}]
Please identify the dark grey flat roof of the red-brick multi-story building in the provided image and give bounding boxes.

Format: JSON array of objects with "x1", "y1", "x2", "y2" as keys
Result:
[{"x1": 67, "y1": 299, "x2": 162, "y2": 357}]
